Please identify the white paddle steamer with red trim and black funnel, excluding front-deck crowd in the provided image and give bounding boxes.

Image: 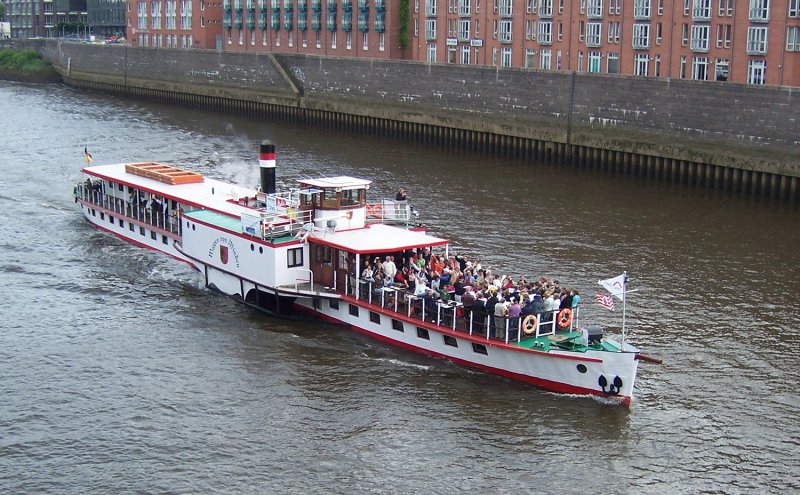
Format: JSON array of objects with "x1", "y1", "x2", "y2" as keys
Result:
[{"x1": 75, "y1": 141, "x2": 641, "y2": 404}]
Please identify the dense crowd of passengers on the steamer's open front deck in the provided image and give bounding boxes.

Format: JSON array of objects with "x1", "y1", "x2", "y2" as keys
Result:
[{"x1": 350, "y1": 248, "x2": 581, "y2": 339}]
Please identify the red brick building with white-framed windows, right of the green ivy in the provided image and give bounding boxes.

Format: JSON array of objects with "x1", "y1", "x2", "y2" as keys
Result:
[{"x1": 412, "y1": 0, "x2": 800, "y2": 86}]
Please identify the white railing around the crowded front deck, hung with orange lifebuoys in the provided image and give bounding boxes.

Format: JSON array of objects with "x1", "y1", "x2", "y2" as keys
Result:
[{"x1": 352, "y1": 277, "x2": 580, "y2": 343}]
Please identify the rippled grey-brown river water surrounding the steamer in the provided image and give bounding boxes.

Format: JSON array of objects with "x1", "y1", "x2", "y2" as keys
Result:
[{"x1": 0, "y1": 82, "x2": 800, "y2": 494}]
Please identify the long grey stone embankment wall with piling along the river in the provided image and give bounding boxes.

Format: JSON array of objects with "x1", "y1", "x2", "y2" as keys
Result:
[{"x1": 12, "y1": 40, "x2": 800, "y2": 202}]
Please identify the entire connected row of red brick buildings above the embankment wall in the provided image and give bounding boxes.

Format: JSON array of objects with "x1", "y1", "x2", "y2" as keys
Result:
[{"x1": 128, "y1": 0, "x2": 800, "y2": 86}]
